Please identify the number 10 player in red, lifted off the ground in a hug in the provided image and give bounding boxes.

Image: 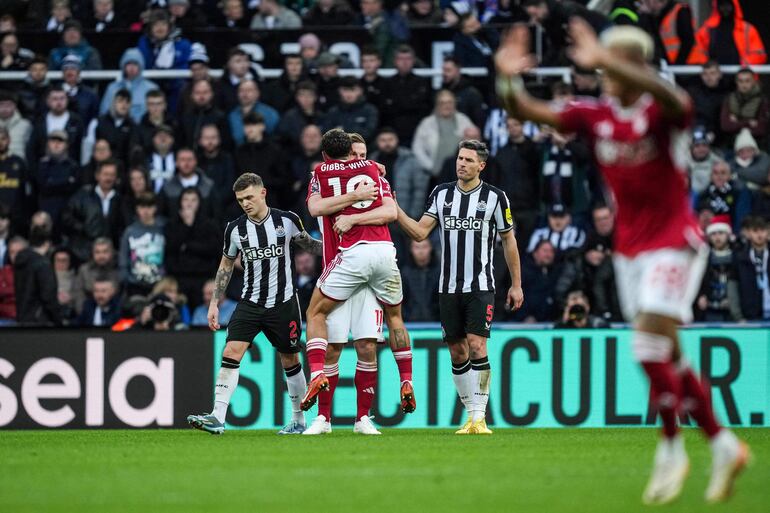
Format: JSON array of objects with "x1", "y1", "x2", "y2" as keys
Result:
[{"x1": 303, "y1": 129, "x2": 415, "y2": 413}]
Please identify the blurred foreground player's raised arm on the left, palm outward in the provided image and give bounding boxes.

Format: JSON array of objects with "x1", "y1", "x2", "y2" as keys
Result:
[{"x1": 495, "y1": 23, "x2": 560, "y2": 130}]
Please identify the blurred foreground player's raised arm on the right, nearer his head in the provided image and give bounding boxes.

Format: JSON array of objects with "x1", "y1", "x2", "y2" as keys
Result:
[{"x1": 570, "y1": 18, "x2": 690, "y2": 119}]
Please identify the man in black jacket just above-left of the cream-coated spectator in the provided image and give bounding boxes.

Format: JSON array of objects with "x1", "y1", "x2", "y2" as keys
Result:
[{"x1": 382, "y1": 45, "x2": 433, "y2": 147}]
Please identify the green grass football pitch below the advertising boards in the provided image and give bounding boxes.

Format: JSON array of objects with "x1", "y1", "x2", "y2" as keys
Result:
[{"x1": 0, "y1": 429, "x2": 770, "y2": 513}]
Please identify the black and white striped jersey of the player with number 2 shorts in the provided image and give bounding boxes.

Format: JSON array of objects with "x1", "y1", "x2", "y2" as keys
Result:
[{"x1": 223, "y1": 208, "x2": 305, "y2": 308}]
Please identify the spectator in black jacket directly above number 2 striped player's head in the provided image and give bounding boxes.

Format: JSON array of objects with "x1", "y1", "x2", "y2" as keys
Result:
[{"x1": 235, "y1": 112, "x2": 294, "y2": 210}]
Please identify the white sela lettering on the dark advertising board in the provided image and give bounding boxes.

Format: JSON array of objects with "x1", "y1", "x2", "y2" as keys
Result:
[{"x1": 0, "y1": 337, "x2": 174, "y2": 428}]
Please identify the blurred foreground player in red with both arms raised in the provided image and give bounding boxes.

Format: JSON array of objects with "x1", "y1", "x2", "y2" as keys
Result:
[{"x1": 495, "y1": 19, "x2": 749, "y2": 504}]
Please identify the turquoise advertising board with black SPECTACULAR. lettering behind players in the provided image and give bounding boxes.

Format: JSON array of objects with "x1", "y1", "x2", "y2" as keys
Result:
[{"x1": 213, "y1": 328, "x2": 770, "y2": 429}]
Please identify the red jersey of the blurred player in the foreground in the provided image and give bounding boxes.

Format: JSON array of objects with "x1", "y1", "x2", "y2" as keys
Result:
[{"x1": 560, "y1": 94, "x2": 703, "y2": 257}]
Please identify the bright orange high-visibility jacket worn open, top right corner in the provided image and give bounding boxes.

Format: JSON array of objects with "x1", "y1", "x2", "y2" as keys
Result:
[{"x1": 687, "y1": 0, "x2": 767, "y2": 66}]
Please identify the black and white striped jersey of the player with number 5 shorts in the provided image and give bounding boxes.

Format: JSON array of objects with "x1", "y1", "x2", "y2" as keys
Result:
[{"x1": 424, "y1": 182, "x2": 513, "y2": 293}]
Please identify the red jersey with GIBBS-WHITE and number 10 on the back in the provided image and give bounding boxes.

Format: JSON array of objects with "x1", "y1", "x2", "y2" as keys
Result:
[{"x1": 308, "y1": 159, "x2": 392, "y2": 253}]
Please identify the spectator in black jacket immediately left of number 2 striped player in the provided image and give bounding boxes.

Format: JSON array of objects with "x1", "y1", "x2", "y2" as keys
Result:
[{"x1": 166, "y1": 187, "x2": 222, "y2": 308}]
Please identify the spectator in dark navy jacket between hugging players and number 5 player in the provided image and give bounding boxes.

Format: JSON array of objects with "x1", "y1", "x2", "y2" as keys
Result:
[{"x1": 401, "y1": 239, "x2": 441, "y2": 322}]
